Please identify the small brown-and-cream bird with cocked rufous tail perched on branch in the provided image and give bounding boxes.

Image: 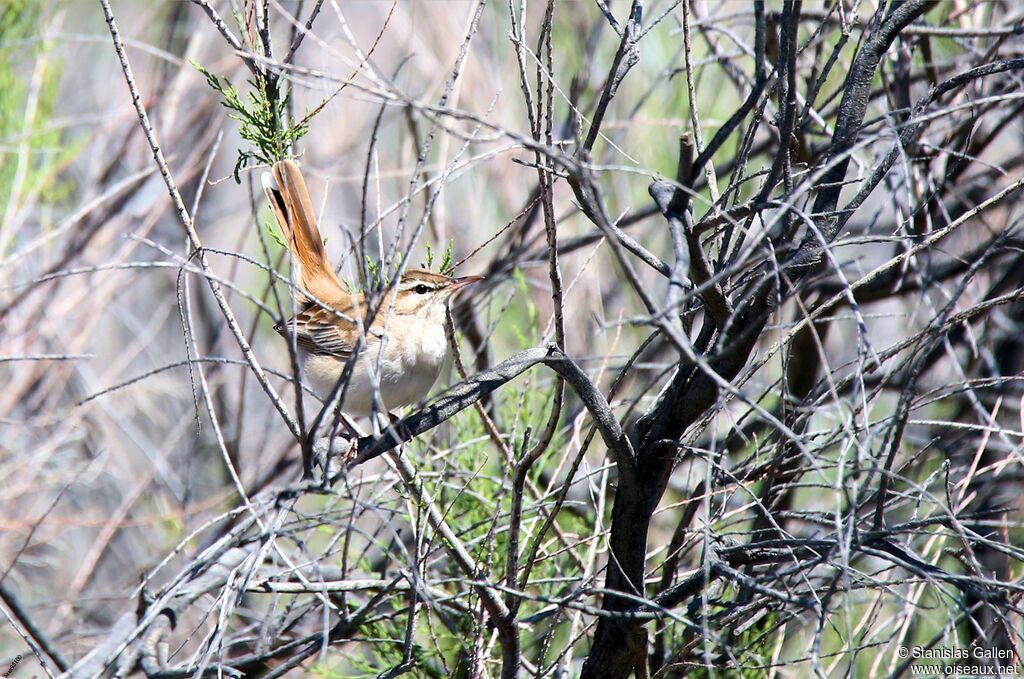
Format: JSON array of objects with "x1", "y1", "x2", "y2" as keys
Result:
[{"x1": 262, "y1": 160, "x2": 482, "y2": 419}]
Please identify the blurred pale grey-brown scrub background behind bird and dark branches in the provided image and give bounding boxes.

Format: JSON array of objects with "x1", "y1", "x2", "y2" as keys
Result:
[{"x1": 6, "y1": 0, "x2": 1024, "y2": 677}]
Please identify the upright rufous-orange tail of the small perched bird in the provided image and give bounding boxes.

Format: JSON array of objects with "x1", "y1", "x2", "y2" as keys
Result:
[{"x1": 262, "y1": 160, "x2": 344, "y2": 300}]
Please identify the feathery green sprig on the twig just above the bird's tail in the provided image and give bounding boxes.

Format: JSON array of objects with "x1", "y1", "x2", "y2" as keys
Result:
[{"x1": 189, "y1": 59, "x2": 307, "y2": 183}]
